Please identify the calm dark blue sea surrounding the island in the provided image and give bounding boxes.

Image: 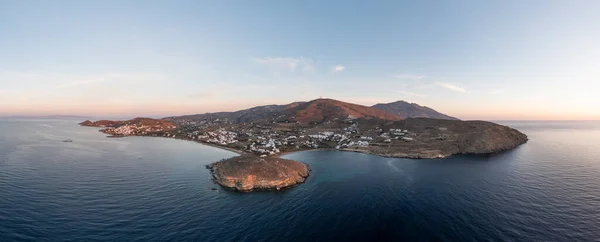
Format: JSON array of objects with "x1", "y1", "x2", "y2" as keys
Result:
[{"x1": 0, "y1": 120, "x2": 600, "y2": 241}]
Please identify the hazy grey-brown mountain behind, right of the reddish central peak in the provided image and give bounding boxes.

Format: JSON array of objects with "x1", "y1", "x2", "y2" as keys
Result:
[{"x1": 372, "y1": 101, "x2": 459, "y2": 120}]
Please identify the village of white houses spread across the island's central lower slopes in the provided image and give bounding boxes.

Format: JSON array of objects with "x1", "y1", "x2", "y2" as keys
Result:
[{"x1": 163, "y1": 116, "x2": 414, "y2": 156}]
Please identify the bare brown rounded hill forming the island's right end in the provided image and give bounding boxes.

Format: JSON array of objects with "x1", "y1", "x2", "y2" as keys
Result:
[{"x1": 344, "y1": 118, "x2": 528, "y2": 158}]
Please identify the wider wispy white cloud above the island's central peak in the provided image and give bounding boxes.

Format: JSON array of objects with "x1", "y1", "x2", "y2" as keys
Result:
[{"x1": 252, "y1": 57, "x2": 315, "y2": 74}]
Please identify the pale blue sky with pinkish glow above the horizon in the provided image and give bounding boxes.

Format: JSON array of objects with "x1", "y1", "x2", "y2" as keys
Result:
[{"x1": 0, "y1": 0, "x2": 600, "y2": 120}]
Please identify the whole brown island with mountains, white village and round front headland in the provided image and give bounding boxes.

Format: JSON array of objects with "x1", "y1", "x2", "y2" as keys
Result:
[{"x1": 80, "y1": 99, "x2": 528, "y2": 191}]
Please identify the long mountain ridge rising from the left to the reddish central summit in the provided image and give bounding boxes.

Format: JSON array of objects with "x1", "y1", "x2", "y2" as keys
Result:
[{"x1": 165, "y1": 99, "x2": 402, "y2": 123}]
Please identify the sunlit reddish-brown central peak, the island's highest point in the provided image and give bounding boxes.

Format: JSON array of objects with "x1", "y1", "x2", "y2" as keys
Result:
[{"x1": 278, "y1": 99, "x2": 402, "y2": 123}]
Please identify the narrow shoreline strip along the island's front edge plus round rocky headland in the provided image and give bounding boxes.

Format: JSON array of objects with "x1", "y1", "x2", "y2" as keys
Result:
[{"x1": 81, "y1": 124, "x2": 524, "y2": 192}]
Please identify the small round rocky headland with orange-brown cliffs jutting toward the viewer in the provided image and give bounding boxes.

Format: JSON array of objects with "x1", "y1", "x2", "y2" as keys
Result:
[{"x1": 208, "y1": 156, "x2": 309, "y2": 191}]
